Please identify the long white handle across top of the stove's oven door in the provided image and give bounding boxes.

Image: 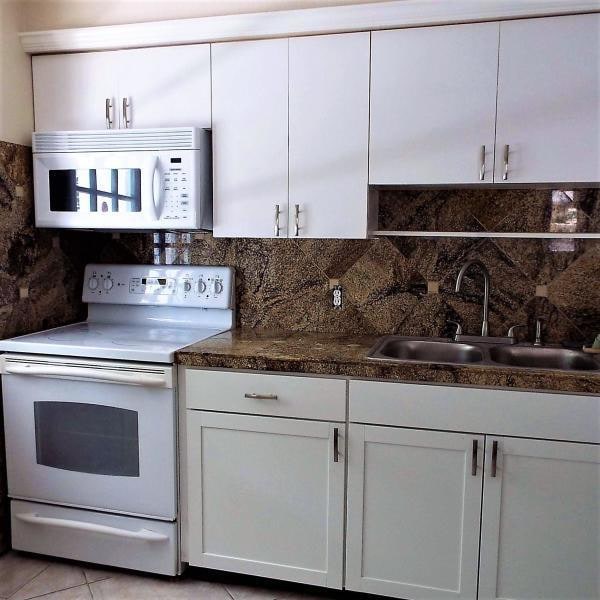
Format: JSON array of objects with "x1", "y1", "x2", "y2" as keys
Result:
[{"x1": 4, "y1": 362, "x2": 169, "y2": 387}]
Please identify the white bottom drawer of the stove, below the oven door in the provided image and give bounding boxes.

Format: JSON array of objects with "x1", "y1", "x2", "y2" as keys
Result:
[{"x1": 11, "y1": 500, "x2": 179, "y2": 575}]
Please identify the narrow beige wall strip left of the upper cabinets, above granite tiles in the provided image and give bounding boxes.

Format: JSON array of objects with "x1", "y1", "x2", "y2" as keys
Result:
[{"x1": 0, "y1": 0, "x2": 33, "y2": 145}]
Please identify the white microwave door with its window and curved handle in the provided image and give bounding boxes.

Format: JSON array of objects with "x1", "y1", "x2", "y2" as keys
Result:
[{"x1": 33, "y1": 151, "x2": 162, "y2": 229}]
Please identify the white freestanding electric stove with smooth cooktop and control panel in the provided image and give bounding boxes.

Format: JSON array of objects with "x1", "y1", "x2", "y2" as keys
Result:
[{"x1": 0, "y1": 265, "x2": 234, "y2": 575}]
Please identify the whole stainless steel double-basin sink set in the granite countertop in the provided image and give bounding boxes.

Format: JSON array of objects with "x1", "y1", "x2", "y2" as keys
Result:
[{"x1": 367, "y1": 335, "x2": 600, "y2": 371}]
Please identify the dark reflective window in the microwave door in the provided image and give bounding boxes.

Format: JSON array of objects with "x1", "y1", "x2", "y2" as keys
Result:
[{"x1": 48, "y1": 169, "x2": 142, "y2": 213}]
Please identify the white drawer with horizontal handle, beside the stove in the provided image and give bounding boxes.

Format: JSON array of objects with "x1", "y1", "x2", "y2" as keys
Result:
[{"x1": 182, "y1": 369, "x2": 346, "y2": 421}]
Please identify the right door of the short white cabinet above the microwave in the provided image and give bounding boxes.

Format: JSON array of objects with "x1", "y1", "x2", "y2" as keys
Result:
[{"x1": 118, "y1": 44, "x2": 211, "y2": 128}]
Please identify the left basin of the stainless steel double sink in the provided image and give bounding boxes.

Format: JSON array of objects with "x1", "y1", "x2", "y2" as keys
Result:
[{"x1": 369, "y1": 335, "x2": 483, "y2": 364}]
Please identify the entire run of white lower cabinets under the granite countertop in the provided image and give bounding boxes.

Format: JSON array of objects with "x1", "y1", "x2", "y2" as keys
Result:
[{"x1": 180, "y1": 368, "x2": 600, "y2": 600}]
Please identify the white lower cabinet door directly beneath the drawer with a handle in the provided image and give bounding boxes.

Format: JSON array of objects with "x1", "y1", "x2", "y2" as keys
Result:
[{"x1": 187, "y1": 410, "x2": 345, "y2": 588}]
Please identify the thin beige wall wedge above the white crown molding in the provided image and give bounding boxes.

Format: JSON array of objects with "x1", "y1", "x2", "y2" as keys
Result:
[{"x1": 19, "y1": 0, "x2": 390, "y2": 30}]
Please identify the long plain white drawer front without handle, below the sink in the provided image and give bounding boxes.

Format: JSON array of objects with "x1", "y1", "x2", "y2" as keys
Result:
[{"x1": 349, "y1": 381, "x2": 600, "y2": 443}]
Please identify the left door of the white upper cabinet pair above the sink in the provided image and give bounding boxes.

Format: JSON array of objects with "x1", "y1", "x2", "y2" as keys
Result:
[{"x1": 369, "y1": 23, "x2": 499, "y2": 184}]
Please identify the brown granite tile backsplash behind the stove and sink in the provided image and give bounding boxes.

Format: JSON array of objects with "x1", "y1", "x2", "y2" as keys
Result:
[{"x1": 0, "y1": 142, "x2": 600, "y2": 551}]
